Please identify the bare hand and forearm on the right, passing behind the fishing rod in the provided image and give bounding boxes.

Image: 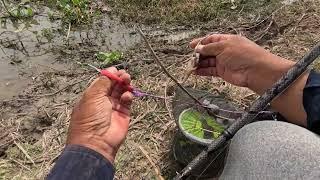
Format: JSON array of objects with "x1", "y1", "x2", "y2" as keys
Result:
[{"x1": 190, "y1": 34, "x2": 308, "y2": 127}]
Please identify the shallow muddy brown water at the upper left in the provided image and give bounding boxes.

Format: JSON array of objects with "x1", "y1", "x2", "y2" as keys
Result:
[{"x1": 0, "y1": 8, "x2": 140, "y2": 100}]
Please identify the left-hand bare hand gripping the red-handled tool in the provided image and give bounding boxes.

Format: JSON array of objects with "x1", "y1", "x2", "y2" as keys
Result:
[{"x1": 67, "y1": 67, "x2": 133, "y2": 163}]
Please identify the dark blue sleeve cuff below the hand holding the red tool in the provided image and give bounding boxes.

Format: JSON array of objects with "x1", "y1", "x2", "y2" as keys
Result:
[{"x1": 46, "y1": 145, "x2": 114, "y2": 180}]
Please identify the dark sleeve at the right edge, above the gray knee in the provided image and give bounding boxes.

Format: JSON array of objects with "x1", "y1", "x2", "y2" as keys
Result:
[{"x1": 303, "y1": 70, "x2": 320, "y2": 134}]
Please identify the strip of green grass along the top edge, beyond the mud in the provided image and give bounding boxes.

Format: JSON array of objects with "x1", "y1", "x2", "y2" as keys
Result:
[{"x1": 107, "y1": 0, "x2": 279, "y2": 25}]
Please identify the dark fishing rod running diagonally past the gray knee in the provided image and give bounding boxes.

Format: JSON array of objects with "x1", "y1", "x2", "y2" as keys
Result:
[{"x1": 174, "y1": 43, "x2": 320, "y2": 180}]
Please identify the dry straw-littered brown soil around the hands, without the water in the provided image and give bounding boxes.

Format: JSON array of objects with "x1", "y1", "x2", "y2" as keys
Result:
[{"x1": 0, "y1": 1, "x2": 320, "y2": 179}]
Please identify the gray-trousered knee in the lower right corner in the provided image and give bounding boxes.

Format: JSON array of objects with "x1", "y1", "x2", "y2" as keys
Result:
[{"x1": 219, "y1": 121, "x2": 320, "y2": 180}]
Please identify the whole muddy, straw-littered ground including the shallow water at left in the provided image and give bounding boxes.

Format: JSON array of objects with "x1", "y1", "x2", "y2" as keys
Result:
[{"x1": 0, "y1": 1, "x2": 320, "y2": 179}]
